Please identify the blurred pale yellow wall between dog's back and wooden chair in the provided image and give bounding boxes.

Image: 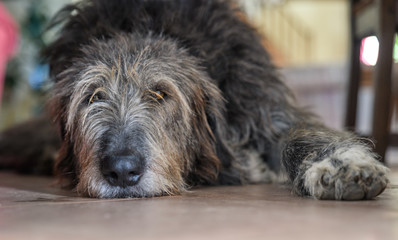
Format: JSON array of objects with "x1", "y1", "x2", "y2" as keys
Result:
[{"x1": 243, "y1": 0, "x2": 350, "y2": 66}]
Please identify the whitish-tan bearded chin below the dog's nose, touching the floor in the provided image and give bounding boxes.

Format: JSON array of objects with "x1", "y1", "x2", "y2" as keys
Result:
[{"x1": 76, "y1": 169, "x2": 183, "y2": 198}]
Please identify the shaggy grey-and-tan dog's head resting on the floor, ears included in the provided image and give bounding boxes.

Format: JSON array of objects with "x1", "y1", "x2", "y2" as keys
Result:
[{"x1": 50, "y1": 33, "x2": 227, "y2": 197}]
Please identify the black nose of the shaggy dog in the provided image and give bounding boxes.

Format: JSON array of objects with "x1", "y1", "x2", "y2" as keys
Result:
[{"x1": 101, "y1": 156, "x2": 143, "y2": 187}]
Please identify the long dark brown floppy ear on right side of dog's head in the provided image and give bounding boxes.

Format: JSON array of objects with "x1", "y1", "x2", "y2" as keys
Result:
[{"x1": 188, "y1": 84, "x2": 239, "y2": 184}]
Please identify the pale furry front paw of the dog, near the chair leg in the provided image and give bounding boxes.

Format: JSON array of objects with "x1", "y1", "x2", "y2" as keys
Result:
[{"x1": 303, "y1": 146, "x2": 388, "y2": 200}]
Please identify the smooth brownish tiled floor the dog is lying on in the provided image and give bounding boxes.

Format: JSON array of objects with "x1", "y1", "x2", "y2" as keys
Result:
[{"x1": 0, "y1": 171, "x2": 398, "y2": 240}]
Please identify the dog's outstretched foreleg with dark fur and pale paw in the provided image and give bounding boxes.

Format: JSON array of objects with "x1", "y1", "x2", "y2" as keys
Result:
[{"x1": 282, "y1": 126, "x2": 388, "y2": 200}]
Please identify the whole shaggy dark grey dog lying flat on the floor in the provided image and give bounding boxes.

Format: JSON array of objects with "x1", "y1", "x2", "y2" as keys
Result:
[{"x1": 0, "y1": 0, "x2": 388, "y2": 200}]
